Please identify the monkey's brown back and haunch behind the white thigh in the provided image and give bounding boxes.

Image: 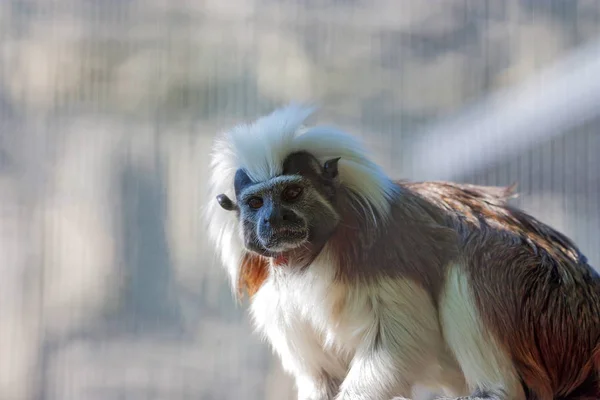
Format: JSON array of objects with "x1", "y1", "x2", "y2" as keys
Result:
[{"x1": 401, "y1": 182, "x2": 600, "y2": 400}]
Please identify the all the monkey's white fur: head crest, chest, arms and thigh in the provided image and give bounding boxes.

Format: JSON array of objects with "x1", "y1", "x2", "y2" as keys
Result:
[{"x1": 206, "y1": 106, "x2": 522, "y2": 400}]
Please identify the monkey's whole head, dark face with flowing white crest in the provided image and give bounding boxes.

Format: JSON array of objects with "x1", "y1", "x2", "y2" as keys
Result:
[{"x1": 206, "y1": 105, "x2": 397, "y2": 285}]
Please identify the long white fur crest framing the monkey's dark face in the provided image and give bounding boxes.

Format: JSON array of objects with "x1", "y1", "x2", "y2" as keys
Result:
[{"x1": 206, "y1": 105, "x2": 395, "y2": 287}]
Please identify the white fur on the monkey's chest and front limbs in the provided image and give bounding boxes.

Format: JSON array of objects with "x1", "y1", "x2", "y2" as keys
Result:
[{"x1": 251, "y1": 252, "x2": 462, "y2": 400}]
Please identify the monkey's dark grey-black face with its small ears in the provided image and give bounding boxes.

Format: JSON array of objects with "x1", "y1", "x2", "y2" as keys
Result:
[{"x1": 217, "y1": 152, "x2": 339, "y2": 259}]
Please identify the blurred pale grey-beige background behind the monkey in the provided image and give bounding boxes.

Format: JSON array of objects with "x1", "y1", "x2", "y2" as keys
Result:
[{"x1": 0, "y1": 0, "x2": 600, "y2": 400}]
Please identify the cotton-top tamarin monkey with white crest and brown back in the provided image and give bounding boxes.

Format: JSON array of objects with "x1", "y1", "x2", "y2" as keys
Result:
[{"x1": 206, "y1": 104, "x2": 600, "y2": 400}]
